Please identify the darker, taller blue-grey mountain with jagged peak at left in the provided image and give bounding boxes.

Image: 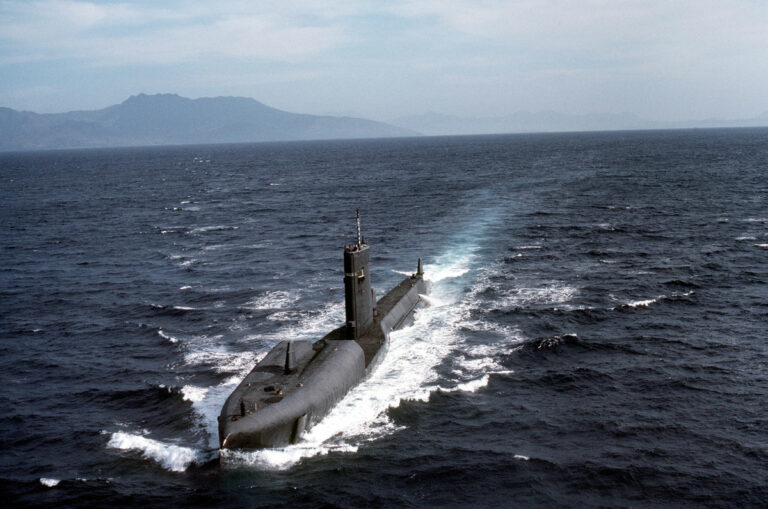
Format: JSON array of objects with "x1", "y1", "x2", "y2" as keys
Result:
[{"x1": 0, "y1": 94, "x2": 419, "y2": 151}]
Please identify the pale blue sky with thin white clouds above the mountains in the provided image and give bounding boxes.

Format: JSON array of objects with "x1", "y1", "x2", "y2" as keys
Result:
[{"x1": 0, "y1": 0, "x2": 768, "y2": 121}]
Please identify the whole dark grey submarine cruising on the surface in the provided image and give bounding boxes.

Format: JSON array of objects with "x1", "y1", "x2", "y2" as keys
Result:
[{"x1": 218, "y1": 211, "x2": 429, "y2": 449}]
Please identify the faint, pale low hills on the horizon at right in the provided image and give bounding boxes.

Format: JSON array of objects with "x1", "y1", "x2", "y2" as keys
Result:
[{"x1": 391, "y1": 111, "x2": 768, "y2": 136}]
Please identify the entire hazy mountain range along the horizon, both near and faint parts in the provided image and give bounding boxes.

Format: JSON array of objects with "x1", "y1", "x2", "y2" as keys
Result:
[{"x1": 0, "y1": 94, "x2": 768, "y2": 151}]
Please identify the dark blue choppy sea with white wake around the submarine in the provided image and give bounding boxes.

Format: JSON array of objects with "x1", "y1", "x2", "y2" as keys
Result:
[{"x1": 0, "y1": 129, "x2": 768, "y2": 507}]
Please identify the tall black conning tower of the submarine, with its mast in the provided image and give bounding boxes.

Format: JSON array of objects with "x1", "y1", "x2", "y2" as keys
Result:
[{"x1": 344, "y1": 210, "x2": 376, "y2": 339}]
